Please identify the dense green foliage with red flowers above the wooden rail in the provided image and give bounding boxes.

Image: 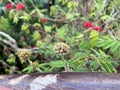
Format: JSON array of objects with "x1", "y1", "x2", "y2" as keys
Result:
[{"x1": 0, "y1": 0, "x2": 120, "y2": 74}]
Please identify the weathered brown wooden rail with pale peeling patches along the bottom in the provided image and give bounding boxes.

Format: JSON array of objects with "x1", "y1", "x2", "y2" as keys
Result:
[{"x1": 0, "y1": 73, "x2": 120, "y2": 90}]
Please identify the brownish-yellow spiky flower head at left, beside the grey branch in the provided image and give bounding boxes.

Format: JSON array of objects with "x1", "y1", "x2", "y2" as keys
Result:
[{"x1": 17, "y1": 49, "x2": 31, "y2": 60}]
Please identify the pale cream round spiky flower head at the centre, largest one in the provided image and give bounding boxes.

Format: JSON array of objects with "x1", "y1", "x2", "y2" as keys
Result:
[{"x1": 54, "y1": 42, "x2": 70, "y2": 55}]
